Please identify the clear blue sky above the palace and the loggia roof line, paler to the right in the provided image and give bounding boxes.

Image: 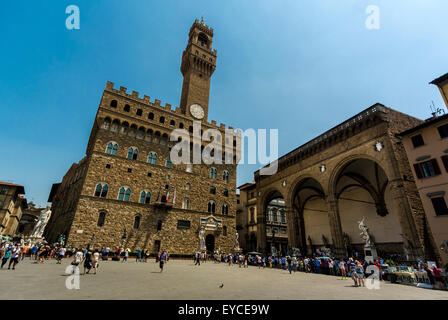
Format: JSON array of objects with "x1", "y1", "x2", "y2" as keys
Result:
[{"x1": 0, "y1": 0, "x2": 448, "y2": 204}]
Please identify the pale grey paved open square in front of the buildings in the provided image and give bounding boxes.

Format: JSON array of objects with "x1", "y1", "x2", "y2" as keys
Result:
[{"x1": 0, "y1": 258, "x2": 448, "y2": 300}]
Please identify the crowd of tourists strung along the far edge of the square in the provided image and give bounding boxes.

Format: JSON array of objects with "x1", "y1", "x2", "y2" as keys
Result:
[{"x1": 0, "y1": 242, "x2": 446, "y2": 289}]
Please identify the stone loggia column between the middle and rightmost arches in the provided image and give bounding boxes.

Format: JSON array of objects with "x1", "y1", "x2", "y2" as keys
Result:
[{"x1": 325, "y1": 195, "x2": 347, "y2": 258}]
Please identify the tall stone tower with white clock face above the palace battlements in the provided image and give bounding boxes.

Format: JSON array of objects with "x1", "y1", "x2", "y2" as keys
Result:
[{"x1": 180, "y1": 19, "x2": 217, "y2": 122}]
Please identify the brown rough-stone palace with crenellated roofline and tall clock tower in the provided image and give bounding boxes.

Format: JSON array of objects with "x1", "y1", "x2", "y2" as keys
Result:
[{"x1": 46, "y1": 20, "x2": 236, "y2": 254}]
